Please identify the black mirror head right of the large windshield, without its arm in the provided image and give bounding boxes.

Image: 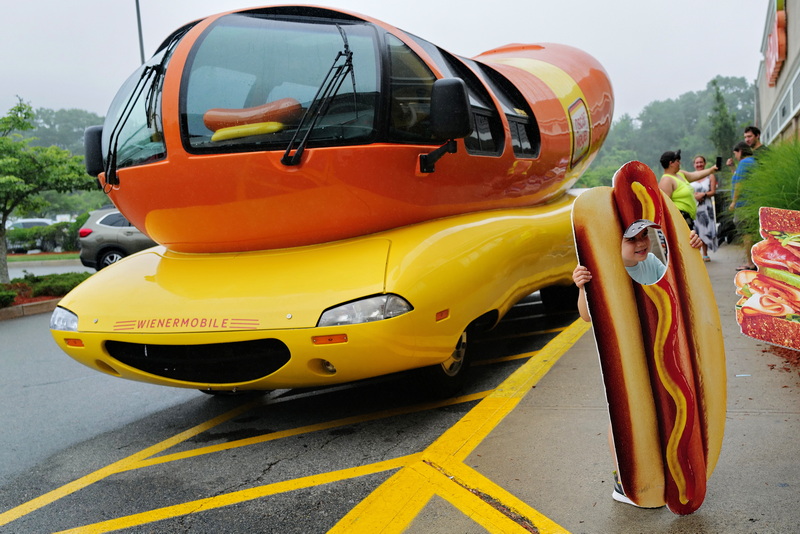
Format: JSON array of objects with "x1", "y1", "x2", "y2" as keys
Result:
[{"x1": 430, "y1": 78, "x2": 474, "y2": 140}]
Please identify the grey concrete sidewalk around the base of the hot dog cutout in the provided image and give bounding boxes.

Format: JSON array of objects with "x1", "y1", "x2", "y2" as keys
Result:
[{"x1": 406, "y1": 246, "x2": 800, "y2": 534}]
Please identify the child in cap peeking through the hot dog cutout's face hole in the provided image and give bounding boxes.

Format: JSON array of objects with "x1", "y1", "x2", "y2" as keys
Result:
[{"x1": 572, "y1": 219, "x2": 703, "y2": 507}]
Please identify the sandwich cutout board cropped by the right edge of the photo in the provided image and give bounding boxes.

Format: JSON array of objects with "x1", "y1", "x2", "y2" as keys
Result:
[{"x1": 734, "y1": 207, "x2": 800, "y2": 350}]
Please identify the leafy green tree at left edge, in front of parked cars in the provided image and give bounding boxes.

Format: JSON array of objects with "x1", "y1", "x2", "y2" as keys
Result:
[{"x1": 0, "y1": 97, "x2": 96, "y2": 283}]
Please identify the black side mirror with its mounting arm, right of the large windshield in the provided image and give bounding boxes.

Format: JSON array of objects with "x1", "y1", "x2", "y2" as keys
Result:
[{"x1": 419, "y1": 78, "x2": 474, "y2": 173}]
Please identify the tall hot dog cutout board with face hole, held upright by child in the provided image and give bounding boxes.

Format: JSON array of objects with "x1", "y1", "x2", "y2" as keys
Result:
[{"x1": 572, "y1": 161, "x2": 726, "y2": 515}]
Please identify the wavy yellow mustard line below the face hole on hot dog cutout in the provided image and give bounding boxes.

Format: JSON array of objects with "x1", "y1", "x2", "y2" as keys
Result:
[{"x1": 641, "y1": 285, "x2": 689, "y2": 504}]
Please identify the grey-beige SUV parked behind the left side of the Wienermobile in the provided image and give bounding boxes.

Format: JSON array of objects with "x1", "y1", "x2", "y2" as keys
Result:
[{"x1": 78, "y1": 208, "x2": 156, "y2": 271}]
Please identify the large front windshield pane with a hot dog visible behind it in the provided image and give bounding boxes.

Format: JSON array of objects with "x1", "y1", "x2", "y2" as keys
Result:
[{"x1": 181, "y1": 14, "x2": 379, "y2": 152}]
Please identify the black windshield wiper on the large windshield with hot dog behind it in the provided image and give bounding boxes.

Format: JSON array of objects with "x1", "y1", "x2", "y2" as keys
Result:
[{"x1": 281, "y1": 24, "x2": 356, "y2": 166}]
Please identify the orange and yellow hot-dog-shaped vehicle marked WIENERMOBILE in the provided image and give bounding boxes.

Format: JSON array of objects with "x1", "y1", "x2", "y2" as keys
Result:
[{"x1": 51, "y1": 6, "x2": 613, "y2": 393}]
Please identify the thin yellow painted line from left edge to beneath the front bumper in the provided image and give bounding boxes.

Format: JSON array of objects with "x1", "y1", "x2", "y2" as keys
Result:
[{"x1": 0, "y1": 399, "x2": 262, "y2": 526}]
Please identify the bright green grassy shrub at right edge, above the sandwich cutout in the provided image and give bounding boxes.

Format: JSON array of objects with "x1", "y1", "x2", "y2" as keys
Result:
[{"x1": 736, "y1": 139, "x2": 800, "y2": 236}]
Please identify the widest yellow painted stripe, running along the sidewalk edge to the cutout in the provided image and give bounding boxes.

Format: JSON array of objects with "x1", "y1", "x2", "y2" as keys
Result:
[{"x1": 329, "y1": 319, "x2": 590, "y2": 534}]
